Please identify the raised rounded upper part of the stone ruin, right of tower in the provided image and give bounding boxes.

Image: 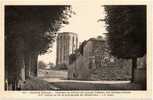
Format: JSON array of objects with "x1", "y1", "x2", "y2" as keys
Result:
[{"x1": 83, "y1": 38, "x2": 117, "y2": 67}]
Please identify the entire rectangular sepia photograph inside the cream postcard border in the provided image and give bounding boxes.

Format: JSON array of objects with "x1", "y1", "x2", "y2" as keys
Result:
[{"x1": 4, "y1": 4, "x2": 148, "y2": 91}]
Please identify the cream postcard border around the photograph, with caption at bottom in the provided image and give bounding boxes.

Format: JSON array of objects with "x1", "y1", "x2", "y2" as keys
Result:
[{"x1": 0, "y1": 0, "x2": 153, "y2": 99}]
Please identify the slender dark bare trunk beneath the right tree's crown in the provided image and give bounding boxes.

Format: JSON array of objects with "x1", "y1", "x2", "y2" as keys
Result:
[{"x1": 131, "y1": 58, "x2": 137, "y2": 83}]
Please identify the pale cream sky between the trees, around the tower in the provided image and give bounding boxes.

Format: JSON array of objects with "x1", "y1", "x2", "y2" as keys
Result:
[{"x1": 38, "y1": 4, "x2": 106, "y2": 64}]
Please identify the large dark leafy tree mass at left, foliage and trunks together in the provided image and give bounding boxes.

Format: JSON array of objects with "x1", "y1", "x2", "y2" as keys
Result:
[{"x1": 5, "y1": 5, "x2": 72, "y2": 88}]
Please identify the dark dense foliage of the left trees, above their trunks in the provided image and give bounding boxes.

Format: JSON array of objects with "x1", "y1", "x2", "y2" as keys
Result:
[{"x1": 5, "y1": 5, "x2": 71, "y2": 53}]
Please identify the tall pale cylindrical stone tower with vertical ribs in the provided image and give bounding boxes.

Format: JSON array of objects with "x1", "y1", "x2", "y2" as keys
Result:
[{"x1": 56, "y1": 32, "x2": 78, "y2": 66}]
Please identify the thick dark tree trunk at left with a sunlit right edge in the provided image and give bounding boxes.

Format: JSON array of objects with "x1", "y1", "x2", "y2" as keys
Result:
[{"x1": 8, "y1": 37, "x2": 25, "y2": 90}]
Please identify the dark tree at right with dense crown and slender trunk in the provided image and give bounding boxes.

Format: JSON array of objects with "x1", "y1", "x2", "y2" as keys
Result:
[{"x1": 104, "y1": 5, "x2": 146, "y2": 82}]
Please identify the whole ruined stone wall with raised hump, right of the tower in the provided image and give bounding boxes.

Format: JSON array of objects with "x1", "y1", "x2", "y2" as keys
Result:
[{"x1": 69, "y1": 38, "x2": 145, "y2": 80}]
